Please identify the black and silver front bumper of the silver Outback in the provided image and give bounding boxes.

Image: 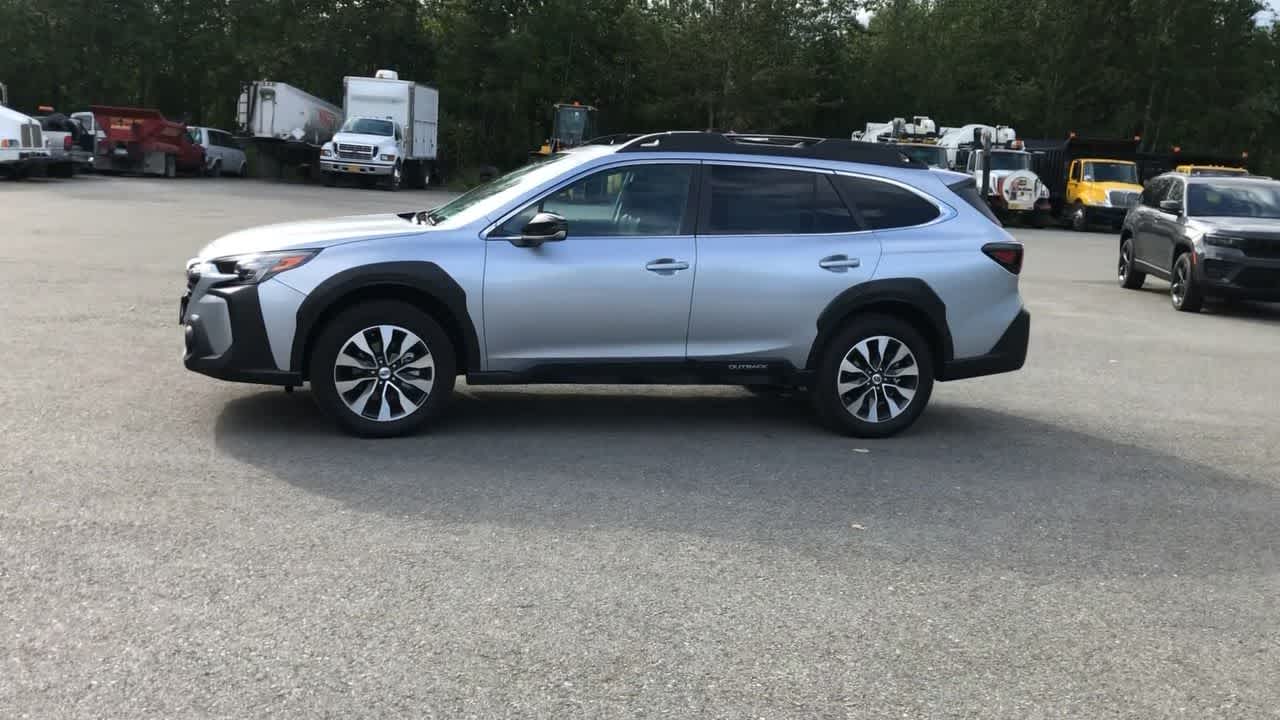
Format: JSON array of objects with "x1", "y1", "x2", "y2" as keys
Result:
[{"x1": 179, "y1": 286, "x2": 302, "y2": 386}]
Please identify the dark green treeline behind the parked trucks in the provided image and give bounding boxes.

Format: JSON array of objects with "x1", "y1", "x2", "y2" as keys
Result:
[{"x1": 0, "y1": 0, "x2": 1280, "y2": 168}]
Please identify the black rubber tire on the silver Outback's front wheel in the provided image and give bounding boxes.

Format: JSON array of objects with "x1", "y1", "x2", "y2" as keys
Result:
[{"x1": 308, "y1": 301, "x2": 457, "y2": 437}]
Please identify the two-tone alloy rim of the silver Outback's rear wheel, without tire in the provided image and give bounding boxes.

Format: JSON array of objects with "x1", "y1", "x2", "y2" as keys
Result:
[{"x1": 836, "y1": 336, "x2": 920, "y2": 423}]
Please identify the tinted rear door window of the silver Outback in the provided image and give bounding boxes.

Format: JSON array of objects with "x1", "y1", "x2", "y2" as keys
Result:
[{"x1": 704, "y1": 165, "x2": 858, "y2": 234}]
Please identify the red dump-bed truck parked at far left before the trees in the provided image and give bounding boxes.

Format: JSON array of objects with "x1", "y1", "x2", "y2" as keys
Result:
[{"x1": 90, "y1": 105, "x2": 206, "y2": 178}]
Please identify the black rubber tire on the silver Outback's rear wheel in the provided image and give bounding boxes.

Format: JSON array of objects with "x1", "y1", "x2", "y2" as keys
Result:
[{"x1": 813, "y1": 314, "x2": 934, "y2": 438}]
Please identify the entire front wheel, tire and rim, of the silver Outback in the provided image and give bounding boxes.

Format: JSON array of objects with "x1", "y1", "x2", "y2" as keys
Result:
[{"x1": 310, "y1": 301, "x2": 457, "y2": 437}]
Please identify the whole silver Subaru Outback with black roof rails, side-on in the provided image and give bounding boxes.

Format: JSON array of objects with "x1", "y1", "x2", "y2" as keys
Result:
[{"x1": 179, "y1": 132, "x2": 1030, "y2": 437}]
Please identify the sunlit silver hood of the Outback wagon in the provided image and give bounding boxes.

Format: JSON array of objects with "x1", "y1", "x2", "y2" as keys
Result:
[{"x1": 197, "y1": 213, "x2": 426, "y2": 260}]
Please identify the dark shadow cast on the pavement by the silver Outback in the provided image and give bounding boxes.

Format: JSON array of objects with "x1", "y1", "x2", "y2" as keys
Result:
[{"x1": 216, "y1": 388, "x2": 1280, "y2": 578}]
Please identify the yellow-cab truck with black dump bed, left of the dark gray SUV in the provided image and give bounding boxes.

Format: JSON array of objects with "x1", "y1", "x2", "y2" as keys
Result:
[{"x1": 1027, "y1": 136, "x2": 1142, "y2": 231}]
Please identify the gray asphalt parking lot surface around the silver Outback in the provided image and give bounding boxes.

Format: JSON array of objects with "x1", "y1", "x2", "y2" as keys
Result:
[{"x1": 0, "y1": 177, "x2": 1280, "y2": 720}]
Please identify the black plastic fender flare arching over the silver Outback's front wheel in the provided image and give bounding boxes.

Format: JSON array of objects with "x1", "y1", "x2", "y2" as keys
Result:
[{"x1": 289, "y1": 260, "x2": 480, "y2": 373}]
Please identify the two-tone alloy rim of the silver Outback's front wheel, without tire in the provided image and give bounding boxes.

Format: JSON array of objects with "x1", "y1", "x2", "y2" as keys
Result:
[{"x1": 333, "y1": 325, "x2": 435, "y2": 423}]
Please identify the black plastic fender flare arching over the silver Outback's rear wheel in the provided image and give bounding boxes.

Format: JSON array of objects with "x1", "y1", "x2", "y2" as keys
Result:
[{"x1": 806, "y1": 278, "x2": 955, "y2": 369}]
